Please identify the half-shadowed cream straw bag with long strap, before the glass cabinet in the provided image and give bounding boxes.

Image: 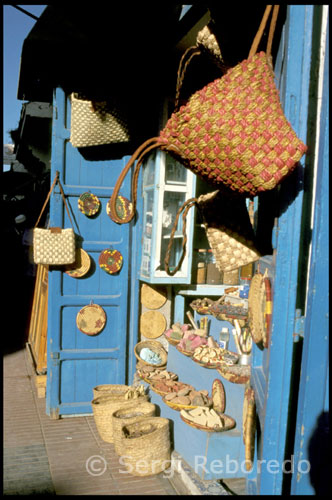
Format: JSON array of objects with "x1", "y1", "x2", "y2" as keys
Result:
[{"x1": 165, "y1": 191, "x2": 261, "y2": 276}]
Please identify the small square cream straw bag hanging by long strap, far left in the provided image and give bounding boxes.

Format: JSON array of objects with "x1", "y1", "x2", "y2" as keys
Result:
[{"x1": 33, "y1": 172, "x2": 76, "y2": 266}]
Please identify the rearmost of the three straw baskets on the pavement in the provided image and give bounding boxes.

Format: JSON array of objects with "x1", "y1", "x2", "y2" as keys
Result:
[{"x1": 91, "y1": 394, "x2": 149, "y2": 443}]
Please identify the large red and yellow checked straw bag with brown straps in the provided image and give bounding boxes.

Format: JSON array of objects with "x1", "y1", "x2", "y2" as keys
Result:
[{"x1": 110, "y1": 5, "x2": 307, "y2": 224}]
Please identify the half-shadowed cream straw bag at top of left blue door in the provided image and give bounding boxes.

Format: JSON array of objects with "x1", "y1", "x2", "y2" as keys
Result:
[{"x1": 70, "y1": 93, "x2": 130, "y2": 148}]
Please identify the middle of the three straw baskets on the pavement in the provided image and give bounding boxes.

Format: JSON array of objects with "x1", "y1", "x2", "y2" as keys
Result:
[{"x1": 112, "y1": 401, "x2": 157, "y2": 456}]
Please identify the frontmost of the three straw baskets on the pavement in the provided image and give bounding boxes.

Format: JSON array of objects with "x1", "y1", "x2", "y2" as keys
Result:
[{"x1": 120, "y1": 417, "x2": 171, "y2": 476}]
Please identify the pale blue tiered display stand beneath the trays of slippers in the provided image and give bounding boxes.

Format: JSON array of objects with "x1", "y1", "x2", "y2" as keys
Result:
[{"x1": 141, "y1": 313, "x2": 245, "y2": 480}]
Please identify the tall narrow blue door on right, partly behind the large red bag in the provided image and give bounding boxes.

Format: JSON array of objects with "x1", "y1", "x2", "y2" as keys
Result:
[{"x1": 247, "y1": 5, "x2": 314, "y2": 495}]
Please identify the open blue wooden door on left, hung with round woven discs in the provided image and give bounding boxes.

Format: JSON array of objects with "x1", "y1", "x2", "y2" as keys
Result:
[{"x1": 46, "y1": 89, "x2": 132, "y2": 418}]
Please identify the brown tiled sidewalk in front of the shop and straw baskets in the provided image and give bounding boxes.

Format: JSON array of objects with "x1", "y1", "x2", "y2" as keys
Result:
[{"x1": 3, "y1": 348, "x2": 188, "y2": 495}]
